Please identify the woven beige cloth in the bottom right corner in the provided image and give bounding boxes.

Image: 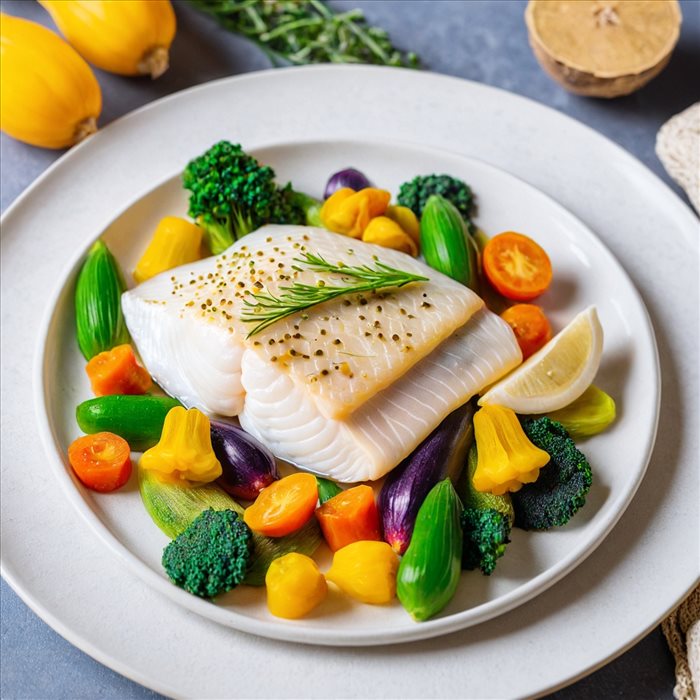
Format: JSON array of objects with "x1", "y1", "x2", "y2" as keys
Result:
[{"x1": 661, "y1": 586, "x2": 700, "y2": 700}]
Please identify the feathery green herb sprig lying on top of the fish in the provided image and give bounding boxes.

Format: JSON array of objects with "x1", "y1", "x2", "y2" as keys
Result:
[{"x1": 241, "y1": 253, "x2": 428, "y2": 338}]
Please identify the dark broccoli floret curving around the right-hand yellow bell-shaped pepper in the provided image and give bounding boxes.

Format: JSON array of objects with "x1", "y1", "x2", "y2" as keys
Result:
[{"x1": 512, "y1": 417, "x2": 592, "y2": 530}]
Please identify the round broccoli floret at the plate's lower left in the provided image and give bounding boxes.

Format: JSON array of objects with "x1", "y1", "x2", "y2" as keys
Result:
[{"x1": 163, "y1": 508, "x2": 253, "y2": 598}]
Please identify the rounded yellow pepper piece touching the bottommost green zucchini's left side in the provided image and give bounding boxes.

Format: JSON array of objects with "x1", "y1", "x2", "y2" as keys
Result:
[{"x1": 326, "y1": 541, "x2": 399, "y2": 605}]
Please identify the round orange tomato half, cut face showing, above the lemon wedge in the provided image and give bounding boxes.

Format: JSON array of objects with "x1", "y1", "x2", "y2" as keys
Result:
[{"x1": 482, "y1": 231, "x2": 552, "y2": 301}]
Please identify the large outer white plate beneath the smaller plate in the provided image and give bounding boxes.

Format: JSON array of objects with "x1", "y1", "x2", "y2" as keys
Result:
[{"x1": 1, "y1": 67, "x2": 698, "y2": 697}]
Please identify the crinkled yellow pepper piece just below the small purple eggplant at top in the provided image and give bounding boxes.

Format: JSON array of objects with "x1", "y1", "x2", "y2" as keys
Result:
[{"x1": 321, "y1": 187, "x2": 391, "y2": 238}]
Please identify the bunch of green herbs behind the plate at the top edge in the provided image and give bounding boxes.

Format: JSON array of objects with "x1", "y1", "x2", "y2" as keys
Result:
[{"x1": 191, "y1": 0, "x2": 419, "y2": 68}]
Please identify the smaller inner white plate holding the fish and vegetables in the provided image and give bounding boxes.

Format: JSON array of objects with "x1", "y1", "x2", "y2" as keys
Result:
[{"x1": 36, "y1": 141, "x2": 659, "y2": 645}]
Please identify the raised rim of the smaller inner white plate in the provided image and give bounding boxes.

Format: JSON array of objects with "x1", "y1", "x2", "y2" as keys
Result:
[{"x1": 33, "y1": 138, "x2": 662, "y2": 646}]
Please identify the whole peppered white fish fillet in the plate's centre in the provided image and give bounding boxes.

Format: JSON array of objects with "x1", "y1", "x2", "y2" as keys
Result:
[{"x1": 122, "y1": 226, "x2": 520, "y2": 482}]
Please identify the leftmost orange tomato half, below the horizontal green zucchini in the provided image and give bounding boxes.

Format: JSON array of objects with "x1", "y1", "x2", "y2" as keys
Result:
[{"x1": 68, "y1": 433, "x2": 131, "y2": 492}]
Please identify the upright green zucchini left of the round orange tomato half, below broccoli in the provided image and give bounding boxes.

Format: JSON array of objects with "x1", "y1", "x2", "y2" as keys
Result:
[{"x1": 420, "y1": 194, "x2": 479, "y2": 291}]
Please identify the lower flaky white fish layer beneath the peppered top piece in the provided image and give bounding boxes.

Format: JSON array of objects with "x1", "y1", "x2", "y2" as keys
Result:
[{"x1": 239, "y1": 309, "x2": 521, "y2": 482}]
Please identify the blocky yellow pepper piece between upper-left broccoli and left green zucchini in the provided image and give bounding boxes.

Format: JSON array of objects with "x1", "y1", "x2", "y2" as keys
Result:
[{"x1": 134, "y1": 216, "x2": 202, "y2": 284}]
